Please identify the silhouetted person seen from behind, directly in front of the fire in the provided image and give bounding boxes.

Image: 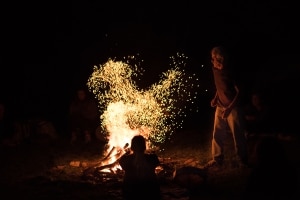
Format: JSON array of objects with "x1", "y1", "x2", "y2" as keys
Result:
[{"x1": 119, "y1": 135, "x2": 161, "y2": 200}]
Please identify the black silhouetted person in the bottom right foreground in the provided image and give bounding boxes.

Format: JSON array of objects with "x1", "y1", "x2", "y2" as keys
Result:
[{"x1": 245, "y1": 137, "x2": 297, "y2": 199}]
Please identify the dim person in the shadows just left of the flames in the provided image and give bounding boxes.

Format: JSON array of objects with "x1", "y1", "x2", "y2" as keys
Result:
[{"x1": 69, "y1": 88, "x2": 100, "y2": 143}]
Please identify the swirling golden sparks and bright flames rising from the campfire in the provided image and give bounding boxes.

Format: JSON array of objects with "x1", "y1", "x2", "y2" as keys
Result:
[{"x1": 87, "y1": 54, "x2": 199, "y2": 152}]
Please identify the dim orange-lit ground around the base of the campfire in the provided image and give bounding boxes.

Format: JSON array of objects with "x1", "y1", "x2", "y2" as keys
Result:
[{"x1": 0, "y1": 130, "x2": 299, "y2": 199}]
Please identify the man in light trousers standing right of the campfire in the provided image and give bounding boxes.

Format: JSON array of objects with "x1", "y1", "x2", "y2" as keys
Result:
[{"x1": 205, "y1": 46, "x2": 248, "y2": 168}]
